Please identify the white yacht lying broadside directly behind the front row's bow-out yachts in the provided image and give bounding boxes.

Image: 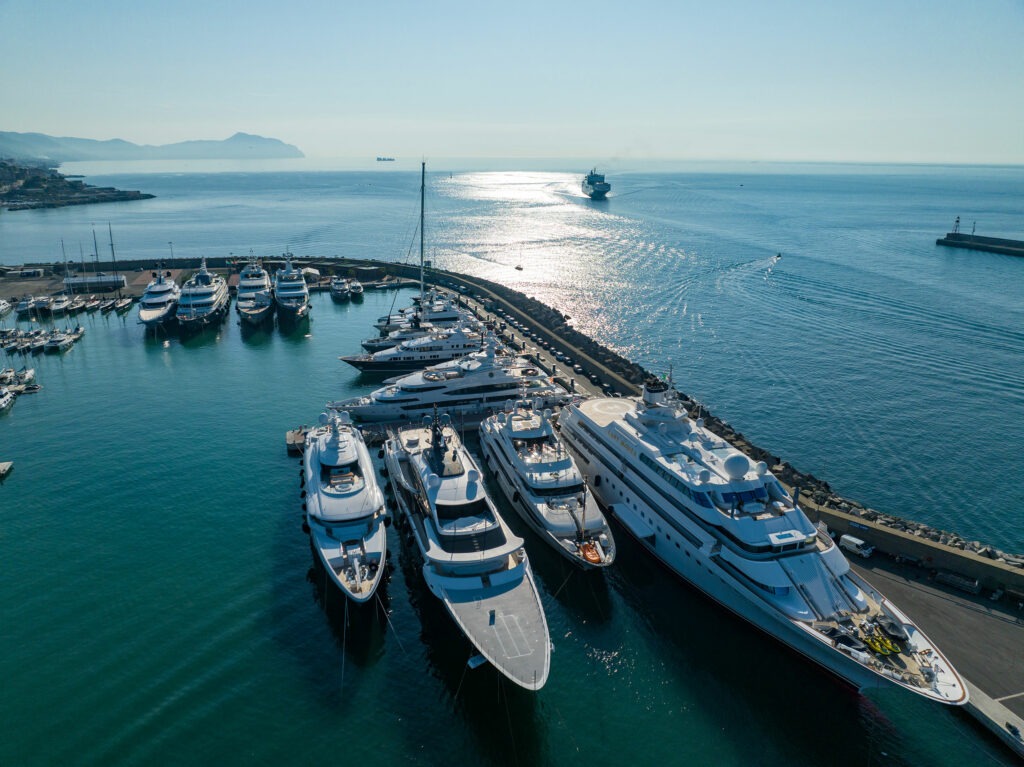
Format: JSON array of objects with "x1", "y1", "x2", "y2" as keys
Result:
[{"x1": 329, "y1": 337, "x2": 570, "y2": 423}]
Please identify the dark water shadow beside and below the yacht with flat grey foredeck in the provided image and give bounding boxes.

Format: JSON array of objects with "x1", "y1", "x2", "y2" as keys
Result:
[{"x1": 395, "y1": 507, "x2": 545, "y2": 765}]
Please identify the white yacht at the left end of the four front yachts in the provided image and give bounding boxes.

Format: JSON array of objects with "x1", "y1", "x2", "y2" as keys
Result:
[{"x1": 302, "y1": 413, "x2": 387, "y2": 602}]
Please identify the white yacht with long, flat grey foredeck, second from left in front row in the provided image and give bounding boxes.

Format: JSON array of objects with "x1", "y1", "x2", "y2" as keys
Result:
[{"x1": 385, "y1": 412, "x2": 551, "y2": 690}]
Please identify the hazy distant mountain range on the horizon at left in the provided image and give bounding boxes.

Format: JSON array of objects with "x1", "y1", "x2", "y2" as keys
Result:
[{"x1": 0, "y1": 131, "x2": 305, "y2": 163}]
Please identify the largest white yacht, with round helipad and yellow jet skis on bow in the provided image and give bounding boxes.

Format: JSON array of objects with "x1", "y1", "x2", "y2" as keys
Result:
[{"x1": 559, "y1": 374, "x2": 968, "y2": 705}]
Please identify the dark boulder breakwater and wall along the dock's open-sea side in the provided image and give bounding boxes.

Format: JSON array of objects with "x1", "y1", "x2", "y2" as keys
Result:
[{"x1": 430, "y1": 272, "x2": 1024, "y2": 600}]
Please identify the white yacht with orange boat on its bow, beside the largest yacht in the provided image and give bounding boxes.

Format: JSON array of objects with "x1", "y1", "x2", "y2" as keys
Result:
[{"x1": 480, "y1": 400, "x2": 615, "y2": 569}]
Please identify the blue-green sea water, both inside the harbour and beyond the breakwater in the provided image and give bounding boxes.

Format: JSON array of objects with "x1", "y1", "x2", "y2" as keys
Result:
[{"x1": 0, "y1": 159, "x2": 1024, "y2": 765}]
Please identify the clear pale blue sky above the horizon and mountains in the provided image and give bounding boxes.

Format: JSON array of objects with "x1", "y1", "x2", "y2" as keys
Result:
[{"x1": 0, "y1": 0, "x2": 1024, "y2": 164}]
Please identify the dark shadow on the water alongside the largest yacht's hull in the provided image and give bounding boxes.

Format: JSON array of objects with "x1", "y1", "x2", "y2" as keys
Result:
[{"x1": 608, "y1": 521, "x2": 1003, "y2": 765}]
